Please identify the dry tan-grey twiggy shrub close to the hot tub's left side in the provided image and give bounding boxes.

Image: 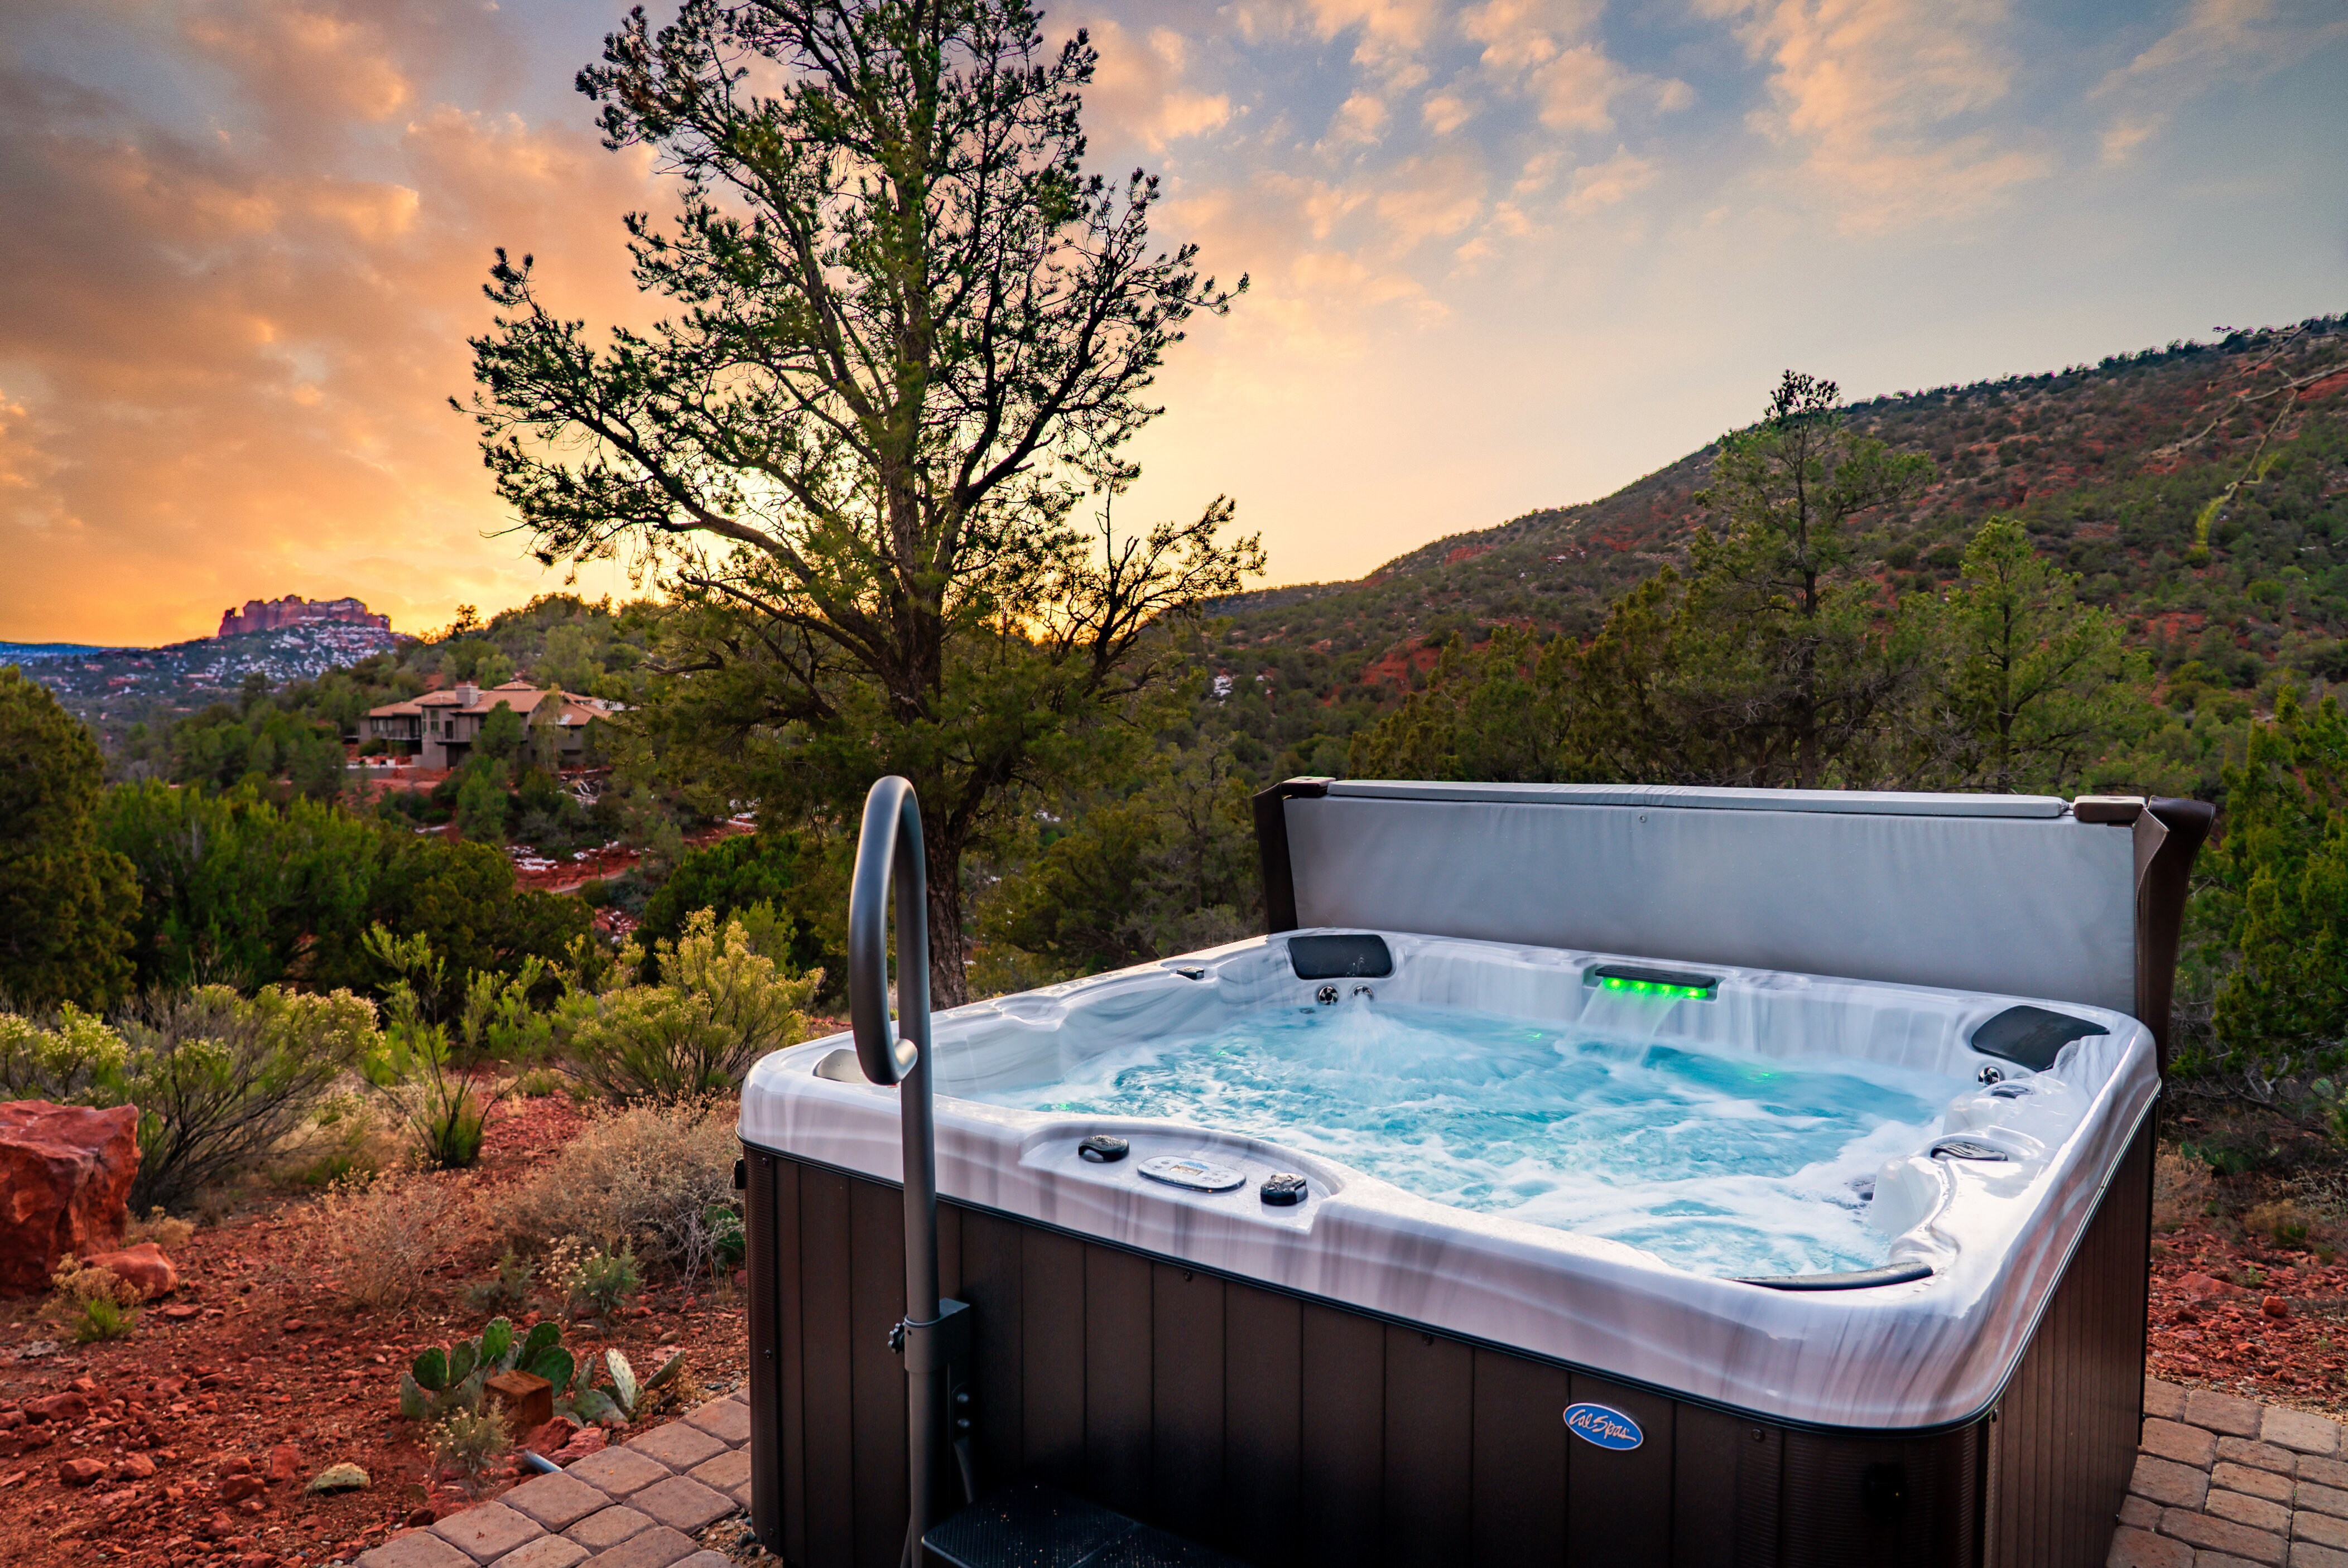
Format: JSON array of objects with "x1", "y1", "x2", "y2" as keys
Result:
[{"x1": 505, "y1": 1098, "x2": 740, "y2": 1279}]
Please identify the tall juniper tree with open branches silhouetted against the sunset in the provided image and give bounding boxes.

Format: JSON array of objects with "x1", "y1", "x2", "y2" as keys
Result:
[{"x1": 472, "y1": 0, "x2": 1263, "y2": 1002}]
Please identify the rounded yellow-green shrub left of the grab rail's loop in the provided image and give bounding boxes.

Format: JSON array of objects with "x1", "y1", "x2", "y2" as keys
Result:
[{"x1": 564, "y1": 909, "x2": 824, "y2": 1101}]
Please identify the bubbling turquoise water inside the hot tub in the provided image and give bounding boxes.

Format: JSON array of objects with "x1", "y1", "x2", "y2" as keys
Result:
[{"x1": 977, "y1": 1000, "x2": 1963, "y2": 1275}]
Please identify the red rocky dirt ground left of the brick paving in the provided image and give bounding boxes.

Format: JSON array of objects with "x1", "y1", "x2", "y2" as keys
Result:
[{"x1": 0, "y1": 1096, "x2": 747, "y2": 1568}]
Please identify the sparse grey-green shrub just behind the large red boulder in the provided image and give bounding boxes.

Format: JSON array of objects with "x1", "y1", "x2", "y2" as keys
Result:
[{"x1": 0, "y1": 986, "x2": 378, "y2": 1207}]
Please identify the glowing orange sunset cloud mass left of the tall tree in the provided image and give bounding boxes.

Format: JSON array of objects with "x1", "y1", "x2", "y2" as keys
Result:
[{"x1": 0, "y1": 0, "x2": 657, "y2": 641}]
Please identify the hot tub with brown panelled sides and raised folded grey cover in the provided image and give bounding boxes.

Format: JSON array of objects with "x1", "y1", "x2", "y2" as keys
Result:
[{"x1": 742, "y1": 781, "x2": 2207, "y2": 1566}]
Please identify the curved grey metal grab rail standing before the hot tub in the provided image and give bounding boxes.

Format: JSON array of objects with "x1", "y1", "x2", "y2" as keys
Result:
[{"x1": 848, "y1": 775, "x2": 970, "y2": 1568}]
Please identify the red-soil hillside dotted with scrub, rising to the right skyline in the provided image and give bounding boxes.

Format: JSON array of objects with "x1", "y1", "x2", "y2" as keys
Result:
[{"x1": 1207, "y1": 317, "x2": 2348, "y2": 772}]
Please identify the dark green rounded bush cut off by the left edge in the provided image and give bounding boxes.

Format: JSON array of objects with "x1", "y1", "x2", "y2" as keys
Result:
[{"x1": 0, "y1": 664, "x2": 138, "y2": 1007}]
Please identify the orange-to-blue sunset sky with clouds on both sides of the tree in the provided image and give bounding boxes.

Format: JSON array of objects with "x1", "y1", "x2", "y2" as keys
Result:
[{"x1": 0, "y1": 0, "x2": 2348, "y2": 643}]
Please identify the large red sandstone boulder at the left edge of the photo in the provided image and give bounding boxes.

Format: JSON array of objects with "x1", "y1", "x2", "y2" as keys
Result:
[{"x1": 0, "y1": 1101, "x2": 138, "y2": 1291}]
